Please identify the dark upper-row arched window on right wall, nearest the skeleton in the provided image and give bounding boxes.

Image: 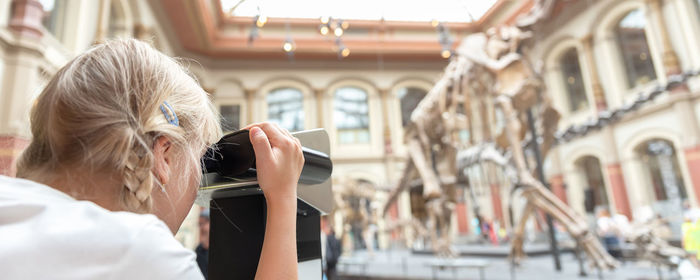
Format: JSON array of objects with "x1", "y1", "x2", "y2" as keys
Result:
[{"x1": 560, "y1": 48, "x2": 588, "y2": 112}]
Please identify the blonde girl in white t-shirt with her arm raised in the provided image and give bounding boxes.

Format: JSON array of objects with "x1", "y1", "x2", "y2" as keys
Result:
[{"x1": 0, "y1": 40, "x2": 304, "y2": 279}]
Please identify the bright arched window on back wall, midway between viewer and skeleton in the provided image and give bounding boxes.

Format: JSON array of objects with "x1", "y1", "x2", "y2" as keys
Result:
[{"x1": 333, "y1": 87, "x2": 369, "y2": 144}]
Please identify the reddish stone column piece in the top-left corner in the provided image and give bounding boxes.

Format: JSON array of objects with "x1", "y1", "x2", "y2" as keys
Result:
[{"x1": 9, "y1": 0, "x2": 44, "y2": 38}]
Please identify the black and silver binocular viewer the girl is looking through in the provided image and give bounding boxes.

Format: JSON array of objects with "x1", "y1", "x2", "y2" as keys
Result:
[{"x1": 196, "y1": 129, "x2": 333, "y2": 280}]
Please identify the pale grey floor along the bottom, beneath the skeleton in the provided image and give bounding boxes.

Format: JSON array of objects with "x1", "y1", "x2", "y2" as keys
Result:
[{"x1": 338, "y1": 250, "x2": 700, "y2": 280}]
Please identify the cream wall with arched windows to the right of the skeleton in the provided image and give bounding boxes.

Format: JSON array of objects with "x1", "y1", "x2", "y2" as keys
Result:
[{"x1": 534, "y1": 0, "x2": 700, "y2": 220}]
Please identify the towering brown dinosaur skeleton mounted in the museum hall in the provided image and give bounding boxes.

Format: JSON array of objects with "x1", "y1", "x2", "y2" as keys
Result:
[{"x1": 385, "y1": 0, "x2": 696, "y2": 269}]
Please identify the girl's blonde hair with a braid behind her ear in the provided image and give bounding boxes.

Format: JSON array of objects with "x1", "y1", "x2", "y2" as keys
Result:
[{"x1": 17, "y1": 39, "x2": 221, "y2": 213}]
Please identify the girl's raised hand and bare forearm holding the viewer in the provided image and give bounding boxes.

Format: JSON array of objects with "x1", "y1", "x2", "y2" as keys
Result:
[{"x1": 246, "y1": 123, "x2": 304, "y2": 280}]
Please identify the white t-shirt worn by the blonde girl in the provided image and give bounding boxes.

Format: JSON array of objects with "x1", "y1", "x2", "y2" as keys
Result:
[{"x1": 0, "y1": 176, "x2": 203, "y2": 280}]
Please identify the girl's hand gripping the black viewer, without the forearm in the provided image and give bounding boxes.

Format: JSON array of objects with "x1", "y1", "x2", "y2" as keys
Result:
[{"x1": 245, "y1": 122, "x2": 304, "y2": 202}]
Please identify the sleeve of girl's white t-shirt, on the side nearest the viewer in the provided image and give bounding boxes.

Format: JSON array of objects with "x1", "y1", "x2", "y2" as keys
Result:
[{"x1": 114, "y1": 220, "x2": 204, "y2": 280}]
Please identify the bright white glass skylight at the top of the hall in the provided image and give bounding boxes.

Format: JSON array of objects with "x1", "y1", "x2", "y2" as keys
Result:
[{"x1": 220, "y1": 0, "x2": 497, "y2": 22}]
